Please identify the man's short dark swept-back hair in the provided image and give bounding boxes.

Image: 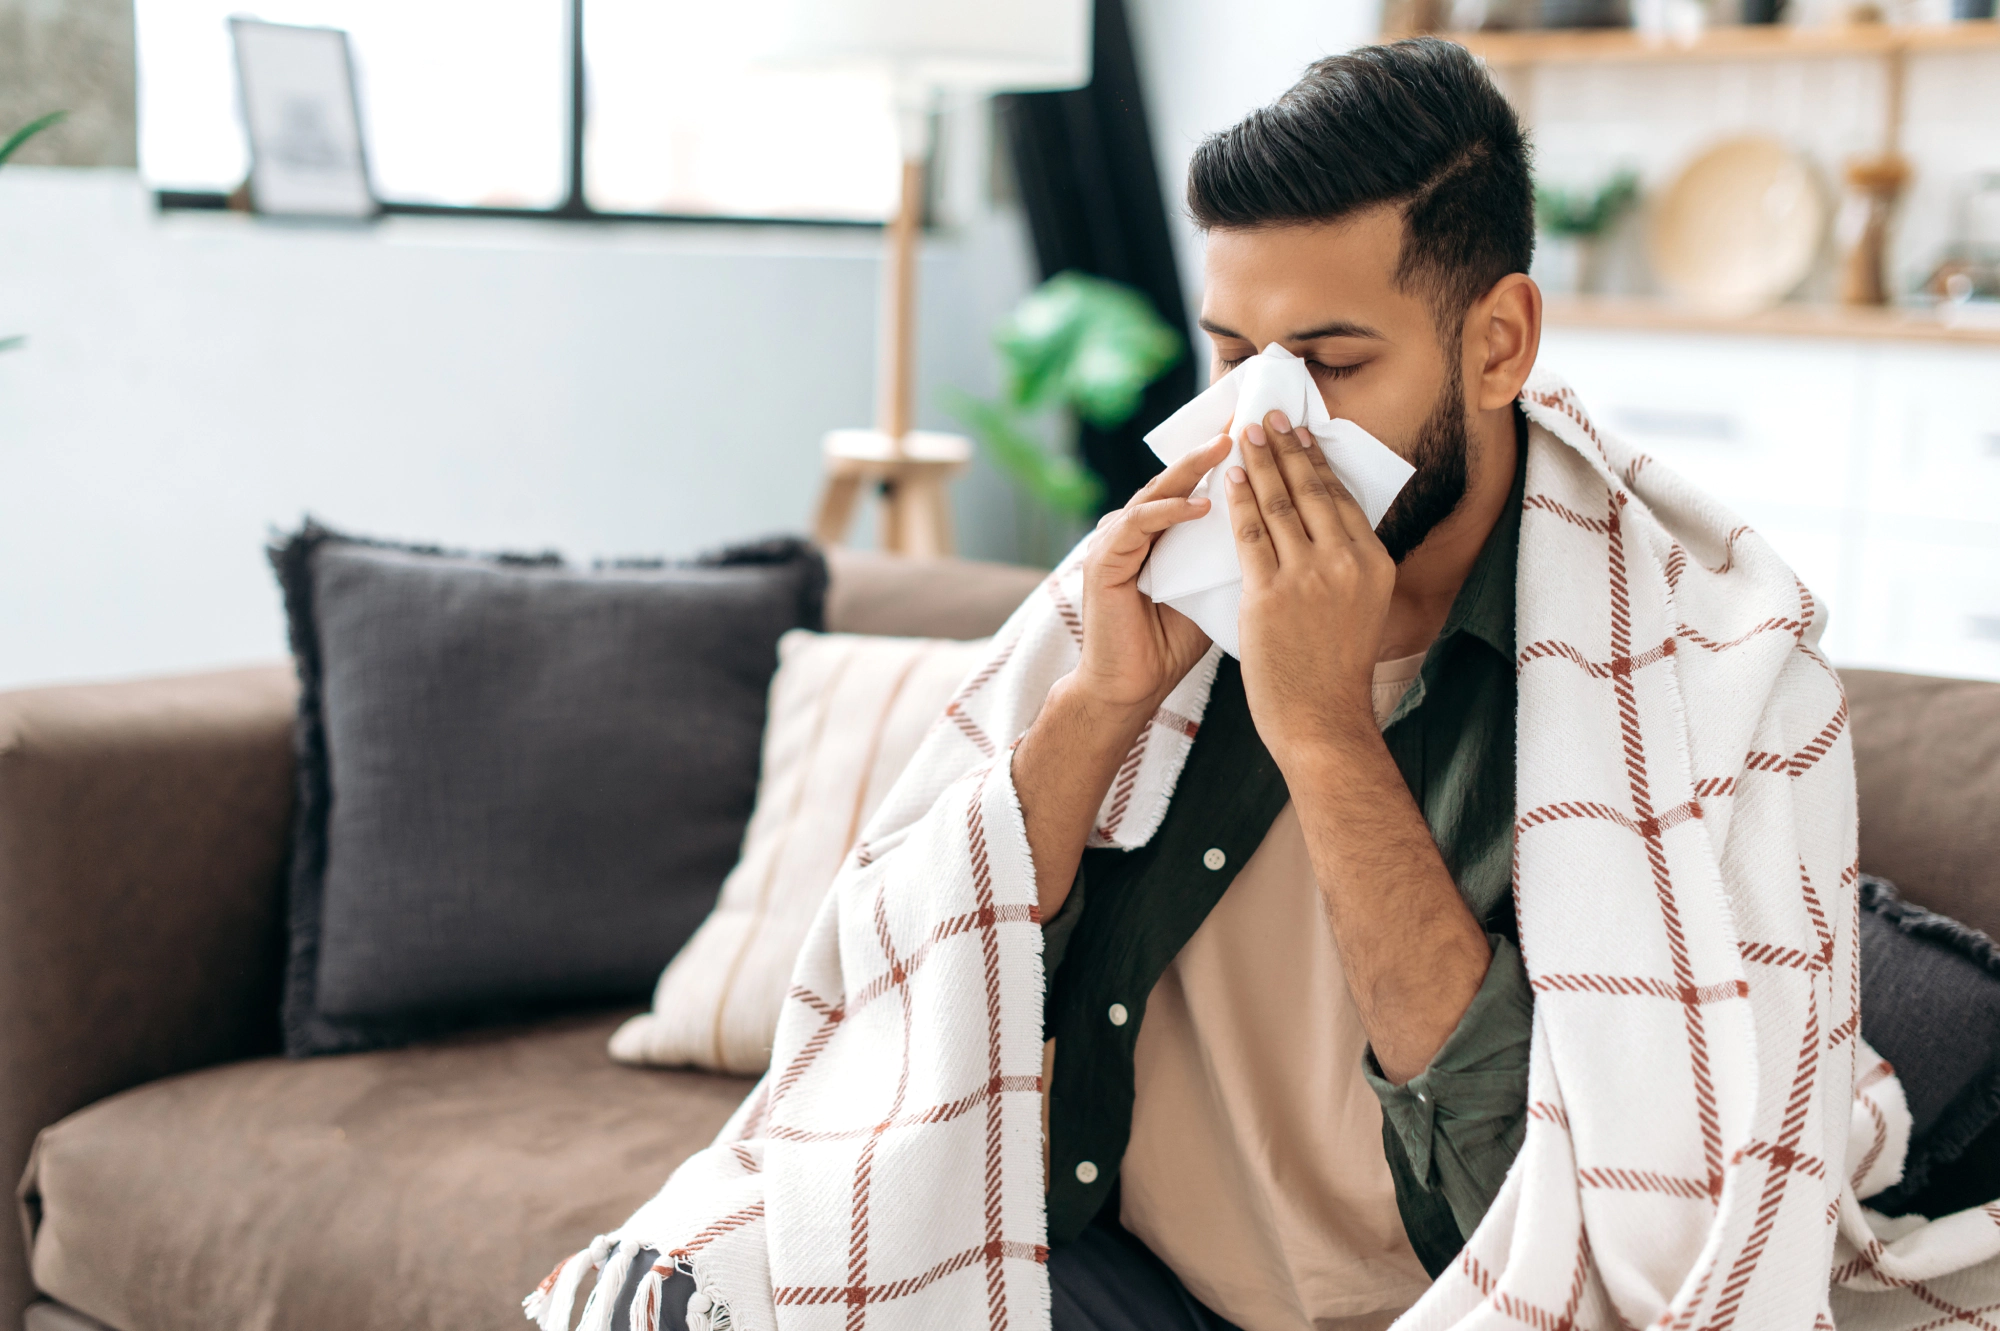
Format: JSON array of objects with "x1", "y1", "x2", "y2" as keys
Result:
[{"x1": 1188, "y1": 38, "x2": 1534, "y2": 338}]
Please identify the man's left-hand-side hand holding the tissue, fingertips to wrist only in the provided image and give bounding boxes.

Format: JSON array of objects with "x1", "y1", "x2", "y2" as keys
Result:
[{"x1": 1072, "y1": 436, "x2": 1230, "y2": 715}]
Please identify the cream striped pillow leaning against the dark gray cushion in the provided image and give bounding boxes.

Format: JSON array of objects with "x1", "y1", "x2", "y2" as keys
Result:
[{"x1": 612, "y1": 630, "x2": 988, "y2": 1073}]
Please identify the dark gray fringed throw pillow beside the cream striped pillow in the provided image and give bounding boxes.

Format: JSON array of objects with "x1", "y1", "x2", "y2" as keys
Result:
[{"x1": 270, "y1": 522, "x2": 826, "y2": 1055}]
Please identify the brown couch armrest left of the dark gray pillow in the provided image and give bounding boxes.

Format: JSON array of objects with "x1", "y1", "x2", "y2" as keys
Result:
[{"x1": 0, "y1": 666, "x2": 296, "y2": 1323}]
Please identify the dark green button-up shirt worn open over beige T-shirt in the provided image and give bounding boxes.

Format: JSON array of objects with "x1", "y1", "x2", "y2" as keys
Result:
[{"x1": 1044, "y1": 437, "x2": 1532, "y2": 1277}]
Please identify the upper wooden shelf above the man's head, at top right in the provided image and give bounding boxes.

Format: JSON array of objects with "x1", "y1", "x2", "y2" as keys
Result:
[{"x1": 1438, "y1": 18, "x2": 2000, "y2": 68}]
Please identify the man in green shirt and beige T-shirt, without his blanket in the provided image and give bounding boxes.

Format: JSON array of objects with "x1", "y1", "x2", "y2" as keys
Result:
[{"x1": 1014, "y1": 33, "x2": 1542, "y2": 1331}]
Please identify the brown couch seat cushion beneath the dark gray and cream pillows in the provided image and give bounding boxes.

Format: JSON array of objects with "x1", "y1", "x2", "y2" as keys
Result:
[{"x1": 22, "y1": 1013, "x2": 750, "y2": 1331}]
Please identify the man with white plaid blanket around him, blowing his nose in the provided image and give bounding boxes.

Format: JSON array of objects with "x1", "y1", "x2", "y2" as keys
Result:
[{"x1": 528, "y1": 40, "x2": 2000, "y2": 1331}]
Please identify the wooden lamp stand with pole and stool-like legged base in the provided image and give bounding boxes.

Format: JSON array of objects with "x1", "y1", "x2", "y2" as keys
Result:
[{"x1": 812, "y1": 136, "x2": 972, "y2": 556}]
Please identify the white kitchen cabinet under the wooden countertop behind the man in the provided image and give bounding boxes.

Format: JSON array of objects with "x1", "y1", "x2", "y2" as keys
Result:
[{"x1": 1542, "y1": 319, "x2": 2000, "y2": 679}]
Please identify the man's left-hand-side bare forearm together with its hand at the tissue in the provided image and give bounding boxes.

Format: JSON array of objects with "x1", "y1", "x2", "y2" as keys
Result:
[{"x1": 1012, "y1": 436, "x2": 1230, "y2": 919}]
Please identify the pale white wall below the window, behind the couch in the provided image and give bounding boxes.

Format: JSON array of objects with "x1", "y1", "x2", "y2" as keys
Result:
[{"x1": 0, "y1": 154, "x2": 1032, "y2": 687}]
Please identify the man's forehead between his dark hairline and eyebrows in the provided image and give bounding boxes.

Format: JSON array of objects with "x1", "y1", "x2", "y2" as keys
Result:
[{"x1": 1202, "y1": 208, "x2": 1428, "y2": 340}]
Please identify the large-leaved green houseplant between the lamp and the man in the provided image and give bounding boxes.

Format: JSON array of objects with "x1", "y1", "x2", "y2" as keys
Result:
[{"x1": 948, "y1": 272, "x2": 1186, "y2": 564}]
